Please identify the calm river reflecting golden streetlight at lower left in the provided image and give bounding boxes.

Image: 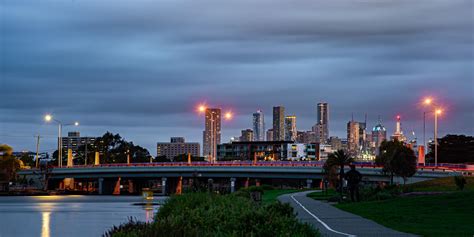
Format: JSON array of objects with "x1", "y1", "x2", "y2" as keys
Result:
[{"x1": 0, "y1": 195, "x2": 167, "y2": 237}]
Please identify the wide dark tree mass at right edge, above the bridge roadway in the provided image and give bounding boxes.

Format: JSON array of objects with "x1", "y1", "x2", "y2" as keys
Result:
[{"x1": 426, "y1": 134, "x2": 474, "y2": 163}]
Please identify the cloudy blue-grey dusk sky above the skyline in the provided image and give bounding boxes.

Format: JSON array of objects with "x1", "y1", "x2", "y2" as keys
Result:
[{"x1": 0, "y1": 0, "x2": 474, "y2": 154}]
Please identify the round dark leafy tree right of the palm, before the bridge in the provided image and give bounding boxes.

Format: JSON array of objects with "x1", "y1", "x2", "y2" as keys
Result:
[{"x1": 375, "y1": 141, "x2": 417, "y2": 184}]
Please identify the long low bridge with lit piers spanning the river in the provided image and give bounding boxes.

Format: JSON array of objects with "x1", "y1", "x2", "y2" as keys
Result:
[{"x1": 19, "y1": 161, "x2": 474, "y2": 194}]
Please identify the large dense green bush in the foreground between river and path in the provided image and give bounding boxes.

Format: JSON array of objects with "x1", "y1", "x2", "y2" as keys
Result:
[{"x1": 103, "y1": 193, "x2": 319, "y2": 237}]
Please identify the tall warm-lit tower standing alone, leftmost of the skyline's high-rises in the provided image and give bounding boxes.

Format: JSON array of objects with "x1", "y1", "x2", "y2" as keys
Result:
[{"x1": 202, "y1": 108, "x2": 221, "y2": 161}]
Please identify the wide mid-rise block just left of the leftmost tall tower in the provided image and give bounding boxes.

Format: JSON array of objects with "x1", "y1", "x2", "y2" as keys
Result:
[{"x1": 156, "y1": 137, "x2": 201, "y2": 160}]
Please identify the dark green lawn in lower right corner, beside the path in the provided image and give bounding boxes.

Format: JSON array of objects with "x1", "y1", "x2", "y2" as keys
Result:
[{"x1": 336, "y1": 191, "x2": 474, "y2": 236}]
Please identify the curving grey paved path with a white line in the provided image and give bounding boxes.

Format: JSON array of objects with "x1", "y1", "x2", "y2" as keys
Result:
[{"x1": 278, "y1": 191, "x2": 416, "y2": 237}]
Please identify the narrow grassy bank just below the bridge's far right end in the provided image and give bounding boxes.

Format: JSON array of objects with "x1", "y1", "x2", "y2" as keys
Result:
[{"x1": 407, "y1": 177, "x2": 474, "y2": 192}]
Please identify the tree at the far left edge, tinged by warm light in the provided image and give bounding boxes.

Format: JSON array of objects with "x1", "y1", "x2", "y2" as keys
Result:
[{"x1": 0, "y1": 144, "x2": 21, "y2": 188}]
